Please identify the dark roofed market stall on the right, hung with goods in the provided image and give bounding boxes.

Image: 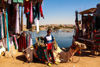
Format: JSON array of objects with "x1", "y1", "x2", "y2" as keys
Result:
[{"x1": 73, "y1": 4, "x2": 100, "y2": 51}]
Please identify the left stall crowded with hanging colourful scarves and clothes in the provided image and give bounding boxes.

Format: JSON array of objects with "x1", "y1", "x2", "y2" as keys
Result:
[{"x1": 0, "y1": 0, "x2": 44, "y2": 55}]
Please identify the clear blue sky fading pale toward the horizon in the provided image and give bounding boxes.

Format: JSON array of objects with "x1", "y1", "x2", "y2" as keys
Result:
[{"x1": 24, "y1": 0, "x2": 100, "y2": 24}]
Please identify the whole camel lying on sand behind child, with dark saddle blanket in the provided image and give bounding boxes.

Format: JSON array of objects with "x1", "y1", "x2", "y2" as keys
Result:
[{"x1": 24, "y1": 37, "x2": 86, "y2": 63}]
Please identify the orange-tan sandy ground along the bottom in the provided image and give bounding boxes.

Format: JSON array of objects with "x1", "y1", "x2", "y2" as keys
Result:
[{"x1": 0, "y1": 53, "x2": 100, "y2": 67}]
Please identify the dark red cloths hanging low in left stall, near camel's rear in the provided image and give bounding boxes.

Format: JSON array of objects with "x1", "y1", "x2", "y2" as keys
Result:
[{"x1": 18, "y1": 36, "x2": 27, "y2": 51}]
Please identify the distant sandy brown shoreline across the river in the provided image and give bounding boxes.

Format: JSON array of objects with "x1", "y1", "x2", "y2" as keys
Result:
[{"x1": 23, "y1": 24, "x2": 75, "y2": 31}]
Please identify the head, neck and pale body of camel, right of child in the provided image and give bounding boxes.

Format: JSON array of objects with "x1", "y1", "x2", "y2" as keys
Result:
[{"x1": 54, "y1": 41, "x2": 86, "y2": 63}]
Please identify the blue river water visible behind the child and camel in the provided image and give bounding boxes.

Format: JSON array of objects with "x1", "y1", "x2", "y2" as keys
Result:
[{"x1": 26, "y1": 30, "x2": 74, "y2": 48}]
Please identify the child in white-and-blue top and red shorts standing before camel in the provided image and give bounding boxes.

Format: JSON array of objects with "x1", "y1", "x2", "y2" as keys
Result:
[{"x1": 44, "y1": 29, "x2": 57, "y2": 66}]
